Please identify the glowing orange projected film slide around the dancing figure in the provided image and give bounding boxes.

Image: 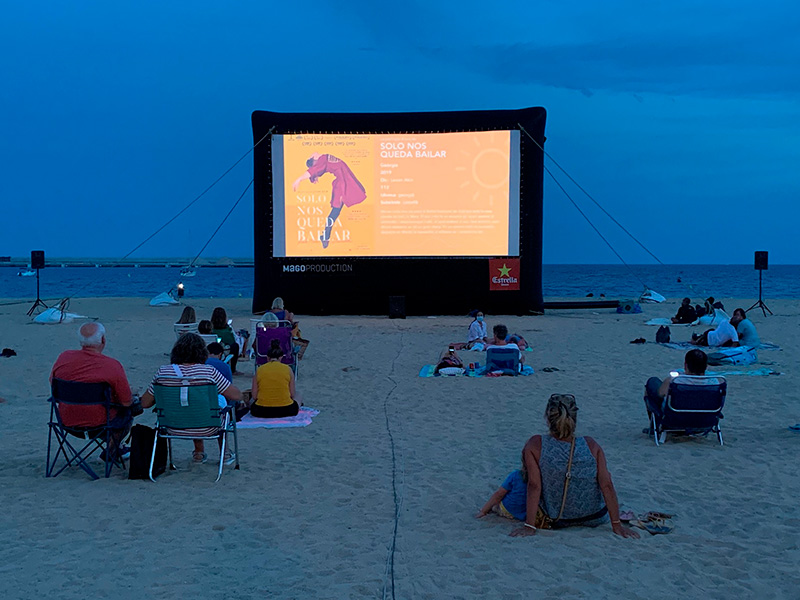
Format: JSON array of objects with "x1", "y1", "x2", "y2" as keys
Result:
[{"x1": 284, "y1": 131, "x2": 511, "y2": 256}]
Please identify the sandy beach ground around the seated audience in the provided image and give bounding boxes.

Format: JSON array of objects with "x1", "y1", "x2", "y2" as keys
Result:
[{"x1": 0, "y1": 298, "x2": 800, "y2": 600}]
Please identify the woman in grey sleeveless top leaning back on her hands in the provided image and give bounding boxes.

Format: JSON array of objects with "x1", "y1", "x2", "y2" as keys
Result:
[{"x1": 511, "y1": 394, "x2": 639, "y2": 538}]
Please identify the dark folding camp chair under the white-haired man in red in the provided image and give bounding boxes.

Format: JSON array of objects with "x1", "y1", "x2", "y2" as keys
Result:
[{"x1": 45, "y1": 379, "x2": 125, "y2": 479}]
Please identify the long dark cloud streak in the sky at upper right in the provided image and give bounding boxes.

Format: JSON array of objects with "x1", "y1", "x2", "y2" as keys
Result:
[{"x1": 420, "y1": 27, "x2": 800, "y2": 98}]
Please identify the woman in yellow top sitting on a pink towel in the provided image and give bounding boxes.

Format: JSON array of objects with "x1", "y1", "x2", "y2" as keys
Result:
[{"x1": 250, "y1": 340, "x2": 302, "y2": 419}]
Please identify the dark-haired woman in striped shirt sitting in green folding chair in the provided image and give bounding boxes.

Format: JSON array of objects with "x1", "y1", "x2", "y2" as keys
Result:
[{"x1": 142, "y1": 333, "x2": 242, "y2": 465}]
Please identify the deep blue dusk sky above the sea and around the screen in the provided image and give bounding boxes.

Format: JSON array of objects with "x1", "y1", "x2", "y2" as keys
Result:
[{"x1": 0, "y1": 0, "x2": 800, "y2": 264}]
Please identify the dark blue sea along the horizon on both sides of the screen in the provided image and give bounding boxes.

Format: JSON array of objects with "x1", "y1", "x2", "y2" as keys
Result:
[{"x1": 0, "y1": 265, "x2": 800, "y2": 303}]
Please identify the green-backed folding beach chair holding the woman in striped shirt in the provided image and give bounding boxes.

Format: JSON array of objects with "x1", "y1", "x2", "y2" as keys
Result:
[{"x1": 149, "y1": 378, "x2": 239, "y2": 481}]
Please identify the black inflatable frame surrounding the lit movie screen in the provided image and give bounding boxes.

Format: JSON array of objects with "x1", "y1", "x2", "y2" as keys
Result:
[{"x1": 252, "y1": 107, "x2": 546, "y2": 315}]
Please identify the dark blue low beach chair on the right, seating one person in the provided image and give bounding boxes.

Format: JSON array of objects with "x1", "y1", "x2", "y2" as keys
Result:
[{"x1": 650, "y1": 375, "x2": 728, "y2": 446}]
